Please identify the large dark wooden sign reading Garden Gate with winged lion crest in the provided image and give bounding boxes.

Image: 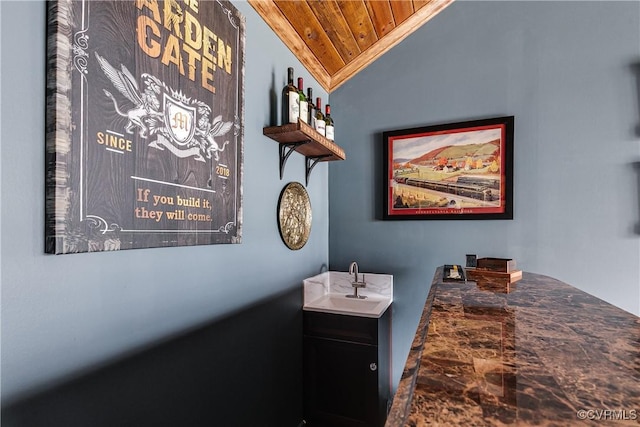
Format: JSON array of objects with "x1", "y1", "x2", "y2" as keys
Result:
[{"x1": 45, "y1": 0, "x2": 245, "y2": 254}]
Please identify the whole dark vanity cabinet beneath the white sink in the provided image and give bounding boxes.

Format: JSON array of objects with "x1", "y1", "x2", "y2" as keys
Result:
[{"x1": 304, "y1": 308, "x2": 391, "y2": 427}]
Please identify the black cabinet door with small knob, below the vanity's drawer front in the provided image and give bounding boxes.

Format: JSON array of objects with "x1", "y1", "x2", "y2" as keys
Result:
[{"x1": 304, "y1": 336, "x2": 381, "y2": 427}]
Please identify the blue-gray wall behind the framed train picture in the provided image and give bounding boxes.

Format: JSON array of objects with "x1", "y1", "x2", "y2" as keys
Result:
[{"x1": 329, "y1": 1, "x2": 640, "y2": 392}]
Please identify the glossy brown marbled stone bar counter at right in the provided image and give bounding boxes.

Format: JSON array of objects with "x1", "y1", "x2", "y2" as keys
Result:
[{"x1": 386, "y1": 268, "x2": 640, "y2": 427}]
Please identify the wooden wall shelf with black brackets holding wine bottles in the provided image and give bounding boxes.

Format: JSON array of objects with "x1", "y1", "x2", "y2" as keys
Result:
[{"x1": 262, "y1": 120, "x2": 346, "y2": 185}]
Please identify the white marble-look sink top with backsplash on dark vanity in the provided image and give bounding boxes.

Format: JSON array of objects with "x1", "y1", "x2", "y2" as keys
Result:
[{"x1": 303, "y1": 271, "x2": 393, "y2": 318}]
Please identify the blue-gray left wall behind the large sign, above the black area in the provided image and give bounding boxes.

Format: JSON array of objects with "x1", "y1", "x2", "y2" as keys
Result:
[{"x1": 0, "y1": 1, "x2": 328, "y2": 414}]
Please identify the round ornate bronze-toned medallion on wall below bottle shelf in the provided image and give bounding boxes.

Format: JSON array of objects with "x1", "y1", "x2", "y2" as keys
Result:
[{"x1": 278, "y1": 182, "x2": 311, "y2": 250}]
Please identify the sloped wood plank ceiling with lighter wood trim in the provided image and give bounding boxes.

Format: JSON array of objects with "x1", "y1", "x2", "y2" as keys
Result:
[{"x1": 249, "y1": 0, "x2": 453, "y2": 92}]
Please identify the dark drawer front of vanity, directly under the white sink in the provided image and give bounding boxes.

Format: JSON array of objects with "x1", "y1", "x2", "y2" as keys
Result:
[{"x1": 304, "y1": 311, "x2": 378, "y2": 345}]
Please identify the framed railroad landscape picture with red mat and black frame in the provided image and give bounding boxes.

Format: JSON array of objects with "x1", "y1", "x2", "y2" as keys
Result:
[{"x1": 383, "y1": 116, "x2": 514, "y2": 220}]
